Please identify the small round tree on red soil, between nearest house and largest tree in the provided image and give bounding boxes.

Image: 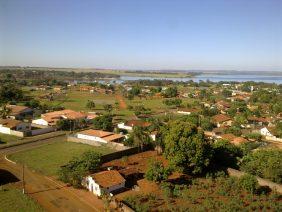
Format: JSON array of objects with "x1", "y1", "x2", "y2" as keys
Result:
[{"x1": 145, "y1": 161, "x2": 171, "y2": 183}]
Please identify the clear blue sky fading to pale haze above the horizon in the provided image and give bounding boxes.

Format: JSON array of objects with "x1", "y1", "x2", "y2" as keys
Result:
[{"x1": 0, "y1": 0, "x2": 282, "y2": 71}]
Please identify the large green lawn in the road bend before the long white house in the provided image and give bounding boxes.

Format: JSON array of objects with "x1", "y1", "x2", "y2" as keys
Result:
[{"x1": 8, "y1": 141, "x2": 114, "y2": 176}]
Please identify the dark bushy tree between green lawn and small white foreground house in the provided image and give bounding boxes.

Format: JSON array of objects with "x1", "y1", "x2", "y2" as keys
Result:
[{"x1": 58, "y1": 151, "x2": 101, "y2": 188}]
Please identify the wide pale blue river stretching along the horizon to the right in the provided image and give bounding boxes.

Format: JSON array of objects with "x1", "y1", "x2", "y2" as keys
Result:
[{"x1": 115, "y1": 74, "x2": 282, "y2": 84}]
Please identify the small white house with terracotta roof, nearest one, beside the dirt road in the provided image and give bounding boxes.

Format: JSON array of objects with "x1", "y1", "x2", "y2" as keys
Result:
[{"x1": 85, "y1": 170, "x2": 125, "y2": 196}]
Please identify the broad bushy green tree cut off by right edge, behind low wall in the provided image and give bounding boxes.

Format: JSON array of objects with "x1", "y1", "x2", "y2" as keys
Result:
[{"x1": 240, "y1": 149, "x2": 282, "y2": 183}]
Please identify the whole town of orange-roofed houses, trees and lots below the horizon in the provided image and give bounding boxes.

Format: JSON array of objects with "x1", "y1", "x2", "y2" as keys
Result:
[{"x1": 0, "y1": 67, "x2": 282, "y2": 211}]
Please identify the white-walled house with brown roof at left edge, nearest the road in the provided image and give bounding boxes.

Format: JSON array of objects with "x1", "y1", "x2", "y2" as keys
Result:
[{"x1": 0, "y1": 119, "x2": 30, "y2": 135}]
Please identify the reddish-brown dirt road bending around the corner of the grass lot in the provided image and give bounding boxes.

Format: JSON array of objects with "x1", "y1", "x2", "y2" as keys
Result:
[{"x1": 0, "y1": 139, "x2": 103, "y2": 211}]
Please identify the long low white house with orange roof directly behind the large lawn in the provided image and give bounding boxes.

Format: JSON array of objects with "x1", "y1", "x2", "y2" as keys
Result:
[{"x1": 77, "y1": 129, "x2": 124, "y2": 143}]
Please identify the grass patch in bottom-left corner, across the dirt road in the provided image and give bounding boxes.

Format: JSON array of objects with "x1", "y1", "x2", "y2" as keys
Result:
[{"x1": 0, "y1": 185, "x2": 44, "y2": 212}]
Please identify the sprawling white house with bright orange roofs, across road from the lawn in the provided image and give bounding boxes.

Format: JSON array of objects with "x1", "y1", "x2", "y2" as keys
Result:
[{"x1": 32, "y1": 110, "x2": 87, "y2": 126}]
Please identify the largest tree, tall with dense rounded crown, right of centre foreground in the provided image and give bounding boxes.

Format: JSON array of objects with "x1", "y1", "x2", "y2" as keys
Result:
[{"x1": 164, "y1": 120, "x2": 212, "y2": 174}]
